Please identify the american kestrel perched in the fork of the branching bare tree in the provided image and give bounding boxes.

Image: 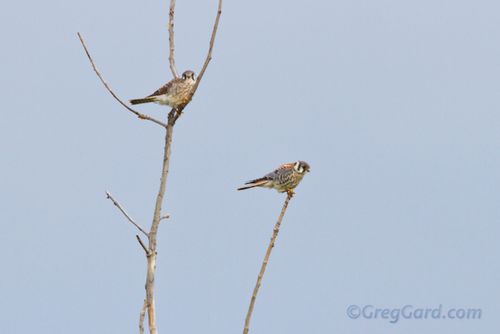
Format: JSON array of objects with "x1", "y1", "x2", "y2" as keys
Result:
[{"x1": 130, "y1": 70, "x2": 196, "y2": 109}]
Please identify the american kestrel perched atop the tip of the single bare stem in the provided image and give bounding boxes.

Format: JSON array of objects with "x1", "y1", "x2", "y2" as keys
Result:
[{"x1": 238, "y1": 160, "x2": 311, "y2": 195}]
